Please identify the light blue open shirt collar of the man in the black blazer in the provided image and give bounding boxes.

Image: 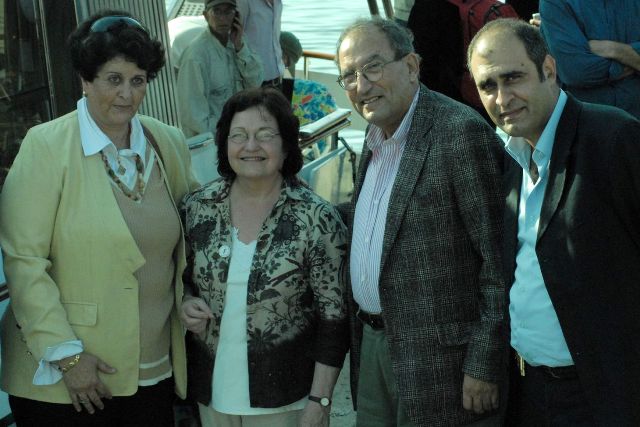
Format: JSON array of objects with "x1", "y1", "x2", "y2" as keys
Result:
[{"x1": 505, "y1": 90, "x2": 567, "y2": 176}]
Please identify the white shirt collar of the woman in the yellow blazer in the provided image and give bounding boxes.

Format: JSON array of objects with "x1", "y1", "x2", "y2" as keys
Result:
[{"x1": 77, "y1": 97, "x2": 147, "y2": 159}]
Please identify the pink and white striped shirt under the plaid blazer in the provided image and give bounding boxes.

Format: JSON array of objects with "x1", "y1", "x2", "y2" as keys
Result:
[{"x1": 350, "y1": 90, "x2": 420, "y2": 313}]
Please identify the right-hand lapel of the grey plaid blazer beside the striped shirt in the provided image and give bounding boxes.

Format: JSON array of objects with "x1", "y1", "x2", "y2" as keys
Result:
[{"x1": 380, "y1": 86, "x2": 434, "y2": 271}]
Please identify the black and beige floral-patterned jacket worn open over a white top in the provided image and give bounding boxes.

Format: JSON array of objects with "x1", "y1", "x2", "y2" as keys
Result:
[{"x1": 181, "y1": 179, "x2": 348, "y2": 408}]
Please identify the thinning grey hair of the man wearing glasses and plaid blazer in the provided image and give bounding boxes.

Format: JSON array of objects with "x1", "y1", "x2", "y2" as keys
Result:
[{"x1": 335, "y1": 17, "x2": 415, "y2": 69}]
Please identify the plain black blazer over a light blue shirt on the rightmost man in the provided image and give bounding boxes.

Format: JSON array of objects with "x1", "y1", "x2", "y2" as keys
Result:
[{"x1": 504, "y1": 95, "x2": 640, "y2": 427}]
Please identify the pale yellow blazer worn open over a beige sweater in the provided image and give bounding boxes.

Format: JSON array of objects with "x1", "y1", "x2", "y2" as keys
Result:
[{"x1": 0, "y1": 111, "x2": 196, "y2": 403}]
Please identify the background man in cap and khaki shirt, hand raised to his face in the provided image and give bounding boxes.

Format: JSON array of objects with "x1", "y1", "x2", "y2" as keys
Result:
[{"x1": 178, "y1": 0, "x2": 264, "y2": 138}]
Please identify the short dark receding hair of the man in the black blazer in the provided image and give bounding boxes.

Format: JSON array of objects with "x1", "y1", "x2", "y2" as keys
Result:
[{"x1": 467, "y1": 18, "x2": 549, "y2": 81}]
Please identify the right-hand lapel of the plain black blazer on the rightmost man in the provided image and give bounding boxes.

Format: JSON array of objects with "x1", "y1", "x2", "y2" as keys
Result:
[{"x1": 538, "y1": 94, "x2": 580, "y2": 240}]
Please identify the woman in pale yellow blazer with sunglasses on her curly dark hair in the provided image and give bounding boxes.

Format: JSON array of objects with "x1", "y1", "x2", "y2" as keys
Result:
[{"x1": 0, "y1": 11, "x2": 194, "y2": 426}]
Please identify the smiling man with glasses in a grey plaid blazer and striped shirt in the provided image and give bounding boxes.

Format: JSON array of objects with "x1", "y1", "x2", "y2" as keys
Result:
[{"x1": 337, "y1": 19, "x2": 506, "y2": 427}]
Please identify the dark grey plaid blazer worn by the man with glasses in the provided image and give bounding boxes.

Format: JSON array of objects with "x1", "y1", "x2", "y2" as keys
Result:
[{"x1": 347, "y1": 86, "x2": 506, "y2": 426}]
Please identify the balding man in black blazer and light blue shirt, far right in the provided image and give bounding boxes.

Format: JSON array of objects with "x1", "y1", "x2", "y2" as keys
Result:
[{"x1": 468, "y1": 20, "x2": 640, "y2": 426}]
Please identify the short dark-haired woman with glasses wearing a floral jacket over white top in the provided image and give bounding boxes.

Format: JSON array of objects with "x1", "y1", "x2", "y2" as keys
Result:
[{"x1": 182, "y1": 88, "x2": 348, "y2": 427}]
